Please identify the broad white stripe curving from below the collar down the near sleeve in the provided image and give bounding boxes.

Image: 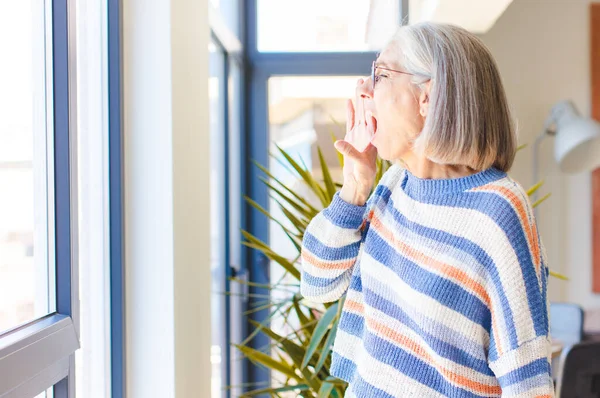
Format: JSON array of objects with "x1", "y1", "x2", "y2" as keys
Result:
[{"x1": 392, "y1": 189, "x2": 535, "y2": 343}]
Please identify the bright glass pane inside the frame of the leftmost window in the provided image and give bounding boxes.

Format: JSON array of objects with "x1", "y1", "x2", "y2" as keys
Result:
[{"x1": 0, "y1": 1, "x2": 55, "y2": 334}]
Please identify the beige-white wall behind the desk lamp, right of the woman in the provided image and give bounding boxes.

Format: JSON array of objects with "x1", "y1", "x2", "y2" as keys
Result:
[{"x1": 482, "y1": 0, "x2": 600, "y2": 307}]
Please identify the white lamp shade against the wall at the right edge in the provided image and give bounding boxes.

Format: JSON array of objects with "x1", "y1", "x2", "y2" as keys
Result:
[{"x1": 551, "y1": 101, "x2": 600, "y2": 173}]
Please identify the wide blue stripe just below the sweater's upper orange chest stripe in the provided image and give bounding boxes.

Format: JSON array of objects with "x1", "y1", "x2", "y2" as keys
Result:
[{"x1": 365, "y1": 230, "x2": 492, "y2": 330}]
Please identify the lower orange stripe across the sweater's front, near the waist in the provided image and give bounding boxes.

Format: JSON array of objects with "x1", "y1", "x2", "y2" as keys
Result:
[{"x1": 367, "y1": 319, "x2": 502, "y2": 395}]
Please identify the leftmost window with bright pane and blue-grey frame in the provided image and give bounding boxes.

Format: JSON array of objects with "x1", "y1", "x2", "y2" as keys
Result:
[{"x1": 0, "y1": 0, "x2": 79, "y2": 398}]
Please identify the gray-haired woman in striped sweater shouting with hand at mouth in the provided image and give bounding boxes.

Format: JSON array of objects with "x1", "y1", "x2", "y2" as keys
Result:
[{"x1": 301, "y1": 23, "x2": 554, "y2": 398}]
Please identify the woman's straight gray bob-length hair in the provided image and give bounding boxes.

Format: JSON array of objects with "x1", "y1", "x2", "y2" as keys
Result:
[{"x1": 388, "y1": 22, "x2": 517, "y2": 171}]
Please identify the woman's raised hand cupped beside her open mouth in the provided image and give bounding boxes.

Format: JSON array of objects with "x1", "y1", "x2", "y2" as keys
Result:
[{"x1": 335, "y1": 79, "x2": 377, "y2": 206}]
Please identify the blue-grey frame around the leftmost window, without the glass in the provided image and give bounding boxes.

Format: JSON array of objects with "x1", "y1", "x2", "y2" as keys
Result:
[{"x1": 0, "y1": 0, "x2": 79, "y2": 398}]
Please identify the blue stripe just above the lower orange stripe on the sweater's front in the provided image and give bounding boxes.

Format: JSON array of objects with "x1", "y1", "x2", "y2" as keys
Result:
[{"x1": 365, "y1": 289, "x2": 494, "y2": 377}]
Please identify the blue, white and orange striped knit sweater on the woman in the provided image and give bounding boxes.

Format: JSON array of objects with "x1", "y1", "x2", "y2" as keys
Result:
[{"x1": 301, "y1": 166, "x2": 554, "y2": 398}]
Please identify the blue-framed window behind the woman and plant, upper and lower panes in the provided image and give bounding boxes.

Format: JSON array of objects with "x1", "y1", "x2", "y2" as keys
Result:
[{"x1": 243, "y1": 0, "x2": 408, "y2": 389}]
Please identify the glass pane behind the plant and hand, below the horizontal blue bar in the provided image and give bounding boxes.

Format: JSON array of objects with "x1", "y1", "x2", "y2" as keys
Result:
[{"x1": 268, "y1": 76, "x2": 359, "y2": 386}]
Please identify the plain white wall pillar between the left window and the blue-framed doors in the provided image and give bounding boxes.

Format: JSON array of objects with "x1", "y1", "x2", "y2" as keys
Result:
[{"x1": 123, "y1": 0, "x2": 211, "y2": 398}]
